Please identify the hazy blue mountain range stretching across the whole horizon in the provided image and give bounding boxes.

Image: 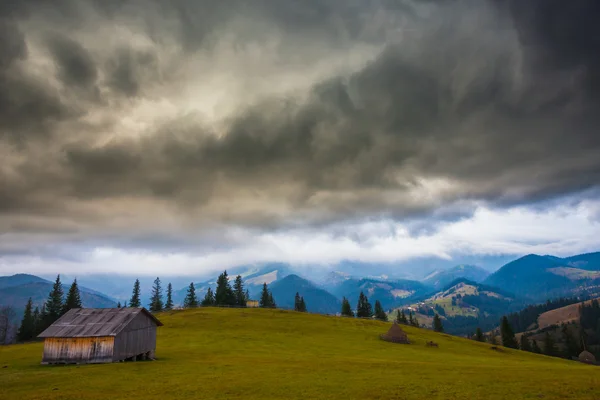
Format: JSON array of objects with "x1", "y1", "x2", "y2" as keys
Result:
[{"x1": 0, "y1": 253, "x2": 600, "y2": 328}]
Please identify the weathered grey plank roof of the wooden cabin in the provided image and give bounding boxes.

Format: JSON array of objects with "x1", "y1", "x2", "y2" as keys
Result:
[{"x1": 38, "y1": 307, "x2": 163, "y2": 338}]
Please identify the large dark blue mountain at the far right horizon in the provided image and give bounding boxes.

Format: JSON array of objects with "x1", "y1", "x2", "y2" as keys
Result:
[{"x1": 484, "y1": 254, "x2": 600, "y2": 301}]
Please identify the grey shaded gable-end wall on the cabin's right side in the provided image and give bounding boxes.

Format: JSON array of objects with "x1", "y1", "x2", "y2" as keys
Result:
[{"x1": 113, "y1": 313, "x2": 156, "y2": 361}]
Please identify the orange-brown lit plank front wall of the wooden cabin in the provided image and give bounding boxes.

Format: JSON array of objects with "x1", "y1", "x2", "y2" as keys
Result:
[{"x1": 42, "y1": 336, "x2": 114, "y2": 364}]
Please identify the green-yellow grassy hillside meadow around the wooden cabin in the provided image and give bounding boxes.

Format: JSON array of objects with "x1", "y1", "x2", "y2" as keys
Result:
[{"x1": 0, "y1": 308, "x2": 600, "y2": 400}]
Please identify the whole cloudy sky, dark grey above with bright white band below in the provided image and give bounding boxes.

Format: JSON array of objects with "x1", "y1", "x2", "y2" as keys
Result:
[{"x1": 0, "y1": 0, "x2": 600, "y2": 275}]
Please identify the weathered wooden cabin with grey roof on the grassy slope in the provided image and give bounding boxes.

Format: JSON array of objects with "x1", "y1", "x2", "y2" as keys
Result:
[{"x1": 38, "y1": 308, "x2": 163, "y2": 364}]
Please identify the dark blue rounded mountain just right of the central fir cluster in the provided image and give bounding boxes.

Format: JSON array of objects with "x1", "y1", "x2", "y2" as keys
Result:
[{"x1": 270, "y1": 275, "x2": 341, "y2": 314}]
